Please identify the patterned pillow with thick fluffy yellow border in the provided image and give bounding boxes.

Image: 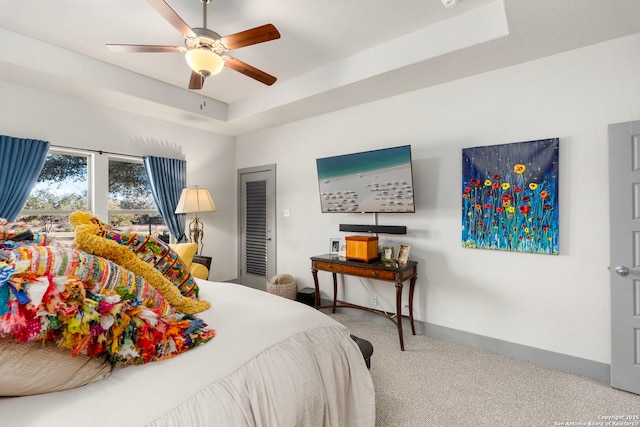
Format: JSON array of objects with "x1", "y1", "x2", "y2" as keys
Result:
[{"x1": 69, "y1": 212, "x2": 211, "y2": 314}]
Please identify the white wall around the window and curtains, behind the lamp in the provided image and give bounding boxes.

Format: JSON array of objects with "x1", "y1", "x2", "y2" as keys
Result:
[{"x1": 0, "y1": 81, "x2": 236, "y2": 280}]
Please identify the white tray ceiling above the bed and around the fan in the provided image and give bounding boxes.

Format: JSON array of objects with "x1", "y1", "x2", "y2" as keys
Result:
[{"x1": 0, "y1": 0, "x2": 640, "y2": 135}]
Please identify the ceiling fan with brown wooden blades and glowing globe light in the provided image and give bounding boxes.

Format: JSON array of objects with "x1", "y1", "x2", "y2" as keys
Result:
[{"x1": 106, "y1": 0, "x2": 280, "y2": 89}]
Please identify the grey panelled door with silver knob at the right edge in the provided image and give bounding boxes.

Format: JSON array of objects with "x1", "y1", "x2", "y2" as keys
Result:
[{"x1": 609, "y1": 121, "x2": 640, "y2": 394}]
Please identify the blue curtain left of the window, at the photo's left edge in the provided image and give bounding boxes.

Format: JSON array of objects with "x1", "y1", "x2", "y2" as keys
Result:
[{"x1": 0, "y1": 135, "x2": 49, "y2": 221}]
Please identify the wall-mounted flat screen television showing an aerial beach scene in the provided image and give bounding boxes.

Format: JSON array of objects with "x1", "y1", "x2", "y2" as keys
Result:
[{"x1": 316, "y1": 145, "x2": 415, "y2": 213}]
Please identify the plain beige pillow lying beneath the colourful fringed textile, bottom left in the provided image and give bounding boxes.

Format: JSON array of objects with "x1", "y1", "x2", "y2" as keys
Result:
[{"x1": 0, "y1": 338, "x2": 112, "y2": 396}]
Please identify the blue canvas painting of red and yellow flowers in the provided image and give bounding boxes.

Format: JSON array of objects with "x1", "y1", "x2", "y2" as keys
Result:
[{"x1": 462, "y1": 138, "x2": 559, "y2": 255}]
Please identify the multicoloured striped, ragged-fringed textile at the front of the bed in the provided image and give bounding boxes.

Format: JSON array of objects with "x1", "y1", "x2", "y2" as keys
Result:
[{"x1": 0, "y1": 219, "x2": 215, "y2": 365}]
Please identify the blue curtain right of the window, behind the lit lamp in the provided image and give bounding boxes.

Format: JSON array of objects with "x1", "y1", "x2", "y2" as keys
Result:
[{"x1": 144, "y1": 156, "x2": 187, "y2": 242}]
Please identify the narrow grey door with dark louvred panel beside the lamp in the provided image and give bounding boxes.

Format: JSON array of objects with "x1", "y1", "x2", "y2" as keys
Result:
[{"x1": 238, "y1": 165, "x2": 276, "y2": 290}]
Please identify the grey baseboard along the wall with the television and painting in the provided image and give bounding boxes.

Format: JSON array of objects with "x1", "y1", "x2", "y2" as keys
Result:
[{"x1": 322, "y1": 300, "x2": 611, "y2": 383}]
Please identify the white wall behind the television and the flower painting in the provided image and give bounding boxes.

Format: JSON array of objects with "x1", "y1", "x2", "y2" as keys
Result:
[{"x1": 236, "y1": 35, "x2": 640, "y2": 363}]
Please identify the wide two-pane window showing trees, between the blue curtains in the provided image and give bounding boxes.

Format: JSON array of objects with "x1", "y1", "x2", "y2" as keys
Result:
[{"x1": 17, "y1": 149, "x2": 168, "y2": 241}]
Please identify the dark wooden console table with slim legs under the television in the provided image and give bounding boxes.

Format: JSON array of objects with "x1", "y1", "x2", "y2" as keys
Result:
[{"x1": 311, "y1": 255, "x2": 418, "y2": 351}]
